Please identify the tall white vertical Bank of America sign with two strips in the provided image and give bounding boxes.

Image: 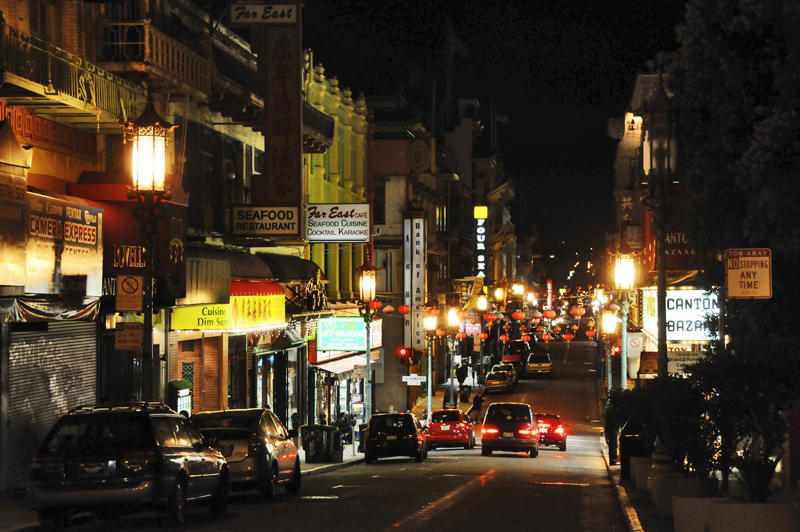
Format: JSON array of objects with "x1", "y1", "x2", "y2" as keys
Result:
[{"x1": 403, "y1": 218, "x2": 427, "y2": 349}]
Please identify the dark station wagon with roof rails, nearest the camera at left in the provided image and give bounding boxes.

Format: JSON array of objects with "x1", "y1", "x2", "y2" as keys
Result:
[{"x1": 28, "y1": 402, "x2": 230, "y2": 524}]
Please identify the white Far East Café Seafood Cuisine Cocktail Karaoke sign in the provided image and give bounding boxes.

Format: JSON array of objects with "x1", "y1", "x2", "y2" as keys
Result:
[{"x1": 306, "y1": 203, "x2": 370, "y2": 242}]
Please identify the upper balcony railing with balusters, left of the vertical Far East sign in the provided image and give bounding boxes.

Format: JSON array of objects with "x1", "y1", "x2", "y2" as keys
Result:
[{"x1": 99, "y1": 20, "x2": 211, "y2": 94}]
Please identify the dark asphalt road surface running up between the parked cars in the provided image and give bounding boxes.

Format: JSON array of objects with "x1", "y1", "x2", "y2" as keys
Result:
[{"x1": 18, "y1": 342, "x2": 627, "y2": 532}]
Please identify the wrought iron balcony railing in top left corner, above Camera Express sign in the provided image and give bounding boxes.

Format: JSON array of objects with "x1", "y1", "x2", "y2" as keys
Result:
[{"x1": 0, "y1": 24, "x2": 147, "y2": 120}]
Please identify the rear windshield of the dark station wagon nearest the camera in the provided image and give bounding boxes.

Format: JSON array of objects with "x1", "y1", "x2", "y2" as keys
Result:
[{"x1": 43, "y1": 413, "x2": 153, "y2": 456}]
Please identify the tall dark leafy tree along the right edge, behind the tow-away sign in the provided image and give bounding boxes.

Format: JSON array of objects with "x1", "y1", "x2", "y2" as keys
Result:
[{"x1": 670, "y1": 0, "x2": 800, "y2": 501}]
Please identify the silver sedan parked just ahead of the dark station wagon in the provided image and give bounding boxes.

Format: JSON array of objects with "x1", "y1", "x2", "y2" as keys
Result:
[{"x1": 192, "y1": 408, "x2": 302, "y2": 498}]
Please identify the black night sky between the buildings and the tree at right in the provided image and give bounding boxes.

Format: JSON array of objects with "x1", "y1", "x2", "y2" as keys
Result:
[{"x1": 303, "y1": 0, "x2": 685, "y2": 253}]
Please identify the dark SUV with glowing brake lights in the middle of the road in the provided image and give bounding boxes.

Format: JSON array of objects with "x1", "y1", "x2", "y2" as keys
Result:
[{"x1": 481, "y1": 403, "x2": 539, "y2": 458}]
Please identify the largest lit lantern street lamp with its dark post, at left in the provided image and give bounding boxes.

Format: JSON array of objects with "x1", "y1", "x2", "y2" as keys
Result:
[{"x1": 123, "y1": 100, "x2": 175, "y2": 401}]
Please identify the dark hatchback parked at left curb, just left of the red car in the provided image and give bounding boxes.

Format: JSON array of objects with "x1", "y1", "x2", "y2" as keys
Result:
[{"x1": 364, "y1": 413, "x2": 428, "y2": 464}]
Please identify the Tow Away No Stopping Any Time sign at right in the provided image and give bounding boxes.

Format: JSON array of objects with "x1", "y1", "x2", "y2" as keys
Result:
[{"x1": 725, "y1": 248, "x2": 772, "y2": 299}]
